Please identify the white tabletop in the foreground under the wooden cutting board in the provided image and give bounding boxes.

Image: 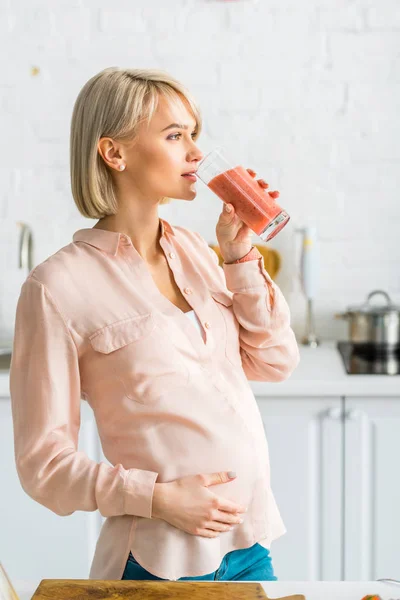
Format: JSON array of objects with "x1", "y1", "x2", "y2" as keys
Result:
[{"x1": 13, "y1": 581, "x2": 400, "y2": 600}]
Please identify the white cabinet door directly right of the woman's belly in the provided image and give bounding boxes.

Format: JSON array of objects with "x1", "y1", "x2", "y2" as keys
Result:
[{"x1": 257, "y1": 397, "x2": 343, "y2": 581}]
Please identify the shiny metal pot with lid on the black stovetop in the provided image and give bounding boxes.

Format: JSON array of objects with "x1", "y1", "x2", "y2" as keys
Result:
[{"x1": 335, "y1": 290, "x2": 400, "y2": 350}]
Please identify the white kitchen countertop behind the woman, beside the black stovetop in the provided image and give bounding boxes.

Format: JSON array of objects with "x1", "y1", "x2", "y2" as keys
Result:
[{"x1": 0, "y1": 341, "x2": 400, "y2": 398}]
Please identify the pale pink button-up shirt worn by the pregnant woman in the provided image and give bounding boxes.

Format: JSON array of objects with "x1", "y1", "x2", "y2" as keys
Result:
[{"x1": 10, "y1": 220, "x2": 299, "y2": 580}]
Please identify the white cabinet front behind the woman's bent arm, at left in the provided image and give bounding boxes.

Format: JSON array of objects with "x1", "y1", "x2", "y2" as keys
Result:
[{"x1": 0, "y1": 398, "x2": 106, "y2": 582}]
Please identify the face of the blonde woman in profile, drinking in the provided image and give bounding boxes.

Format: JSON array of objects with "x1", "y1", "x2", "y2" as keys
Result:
[{"x1": 116, "y1": 96, "x2": 203, "y2": 200}]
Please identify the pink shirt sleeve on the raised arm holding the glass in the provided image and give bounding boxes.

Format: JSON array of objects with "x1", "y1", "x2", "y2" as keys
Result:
[{"x1": 208, "y1": 241, "x2": 300, "y2": 381}]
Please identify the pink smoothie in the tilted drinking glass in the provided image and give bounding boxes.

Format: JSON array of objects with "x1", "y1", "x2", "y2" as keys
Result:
[{"x1": 208, "y1": 166, "x2": 285, "y2": 235}]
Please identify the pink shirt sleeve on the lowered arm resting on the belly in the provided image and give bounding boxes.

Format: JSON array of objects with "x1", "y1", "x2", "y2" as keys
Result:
[{"x1": 10, "y1": 276, "x2": 158, "y2": 518}]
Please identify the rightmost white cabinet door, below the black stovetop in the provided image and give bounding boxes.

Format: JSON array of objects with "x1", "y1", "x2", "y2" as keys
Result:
[{"x1": 344, "y1": 397, "x2": 400, "y2": 581}]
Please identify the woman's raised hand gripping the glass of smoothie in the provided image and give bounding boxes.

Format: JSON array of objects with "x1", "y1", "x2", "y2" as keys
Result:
[{"x1": 215, "y1": 169, "x2": 279, "y2": 263}]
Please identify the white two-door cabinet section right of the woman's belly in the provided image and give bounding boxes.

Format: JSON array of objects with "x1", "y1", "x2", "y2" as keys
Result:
[{"x1": 257, "y1": 397, "x2": 400, "y2": 581}]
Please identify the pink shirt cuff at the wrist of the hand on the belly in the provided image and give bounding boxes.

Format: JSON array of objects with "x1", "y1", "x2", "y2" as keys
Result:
[{"x1": 124, "y1": 469, "x2": 158, "y2": 519}]
